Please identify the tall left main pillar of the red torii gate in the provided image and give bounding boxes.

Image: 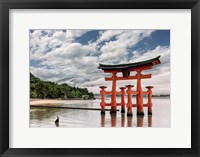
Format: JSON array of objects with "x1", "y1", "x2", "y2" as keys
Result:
[{"x1": 110, "y1": 72, "x2": 117, "y2": 113}]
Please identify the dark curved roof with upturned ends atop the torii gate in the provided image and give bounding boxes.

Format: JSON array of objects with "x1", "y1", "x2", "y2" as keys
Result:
[{"x1": 98, "y1": 56, "x2": 160, "y2": 70}]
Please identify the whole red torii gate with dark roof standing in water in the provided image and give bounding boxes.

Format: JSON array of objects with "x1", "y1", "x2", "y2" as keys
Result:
[{"x1": 98, "y1": 56, "x2": 161, "y2": 116}]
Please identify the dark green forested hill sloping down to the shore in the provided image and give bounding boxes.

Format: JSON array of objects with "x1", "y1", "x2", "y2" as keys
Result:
[{"x1": 30, "y1": 73, "x2": 94, "y2": 99}]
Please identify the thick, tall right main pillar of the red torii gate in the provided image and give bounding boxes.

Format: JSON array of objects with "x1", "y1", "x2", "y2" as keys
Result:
[{"x1": 136, "y1": 70, "x2": 144, "y2": 115}]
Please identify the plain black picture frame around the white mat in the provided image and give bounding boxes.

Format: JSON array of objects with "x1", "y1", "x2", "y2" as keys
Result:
[{"x1": 0, "y1": 0, "x2": 200, "y2": 157}]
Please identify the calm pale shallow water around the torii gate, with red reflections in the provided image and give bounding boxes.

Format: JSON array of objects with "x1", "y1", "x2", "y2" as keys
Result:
[{"x1": 30, "y1": 98, "x2": 171, "y2": 128}]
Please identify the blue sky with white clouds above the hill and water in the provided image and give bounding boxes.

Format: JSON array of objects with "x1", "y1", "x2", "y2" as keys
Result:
[{"x1": 29, "y1": 29, "x2": 170, "y2": 95}]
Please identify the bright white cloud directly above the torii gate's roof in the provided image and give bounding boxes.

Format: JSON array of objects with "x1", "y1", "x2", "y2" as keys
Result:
[{"x1": 99, "y1": 30, "x2": 154, "y2": 62}]
